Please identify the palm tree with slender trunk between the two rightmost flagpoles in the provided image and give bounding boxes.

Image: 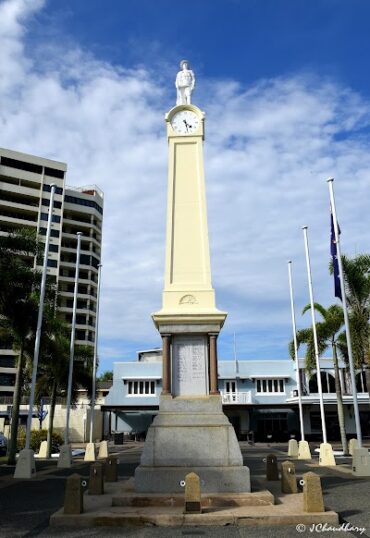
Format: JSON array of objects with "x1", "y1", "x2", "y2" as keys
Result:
[{"x1": 290, "y1": 303, "x2": 348, "y2": 454}]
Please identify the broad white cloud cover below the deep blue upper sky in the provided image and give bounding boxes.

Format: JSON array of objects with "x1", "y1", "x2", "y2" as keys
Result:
[{"x1": 0, "y1": 0, "x2": 370, "y2": 364}]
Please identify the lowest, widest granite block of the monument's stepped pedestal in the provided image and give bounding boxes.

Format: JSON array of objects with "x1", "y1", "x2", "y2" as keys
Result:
[{"x1": 135, "y1": 465, "x2": 251, "y2": 493}]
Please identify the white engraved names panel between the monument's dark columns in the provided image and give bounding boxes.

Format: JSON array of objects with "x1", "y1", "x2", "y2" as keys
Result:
[{"x1": 172, "y1": 336, "x2": 208, "y2": 396}]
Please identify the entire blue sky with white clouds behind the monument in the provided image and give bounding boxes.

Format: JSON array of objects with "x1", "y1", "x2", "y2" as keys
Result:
[{"x1": 0, "y1": 0, "x2": 370, "y2": 370}]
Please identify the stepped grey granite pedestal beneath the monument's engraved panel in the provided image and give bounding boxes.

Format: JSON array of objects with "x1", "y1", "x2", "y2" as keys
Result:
[{"x1": 135, "y1": 395, "x2": 250, "y2": 493}]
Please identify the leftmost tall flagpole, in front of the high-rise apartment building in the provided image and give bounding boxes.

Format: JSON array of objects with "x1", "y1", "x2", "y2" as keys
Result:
[{"x1": 25, "y1": 183, "x2": 55, "y2": 449}]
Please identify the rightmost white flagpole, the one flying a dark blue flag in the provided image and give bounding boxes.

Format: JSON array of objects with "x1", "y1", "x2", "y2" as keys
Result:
[{"x1": 327, "y1": 177, "x2": 362, "y2": 448}]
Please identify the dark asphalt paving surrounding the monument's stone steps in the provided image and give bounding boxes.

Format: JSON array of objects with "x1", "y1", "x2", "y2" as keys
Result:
[{"x1": 0, "y1": 443, "x2": 370, "y2": 538}]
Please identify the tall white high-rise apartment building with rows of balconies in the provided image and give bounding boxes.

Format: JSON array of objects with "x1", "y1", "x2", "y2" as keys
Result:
[{"x1": 0, "y1": 148, "x2": 104, "y2": 398}]
